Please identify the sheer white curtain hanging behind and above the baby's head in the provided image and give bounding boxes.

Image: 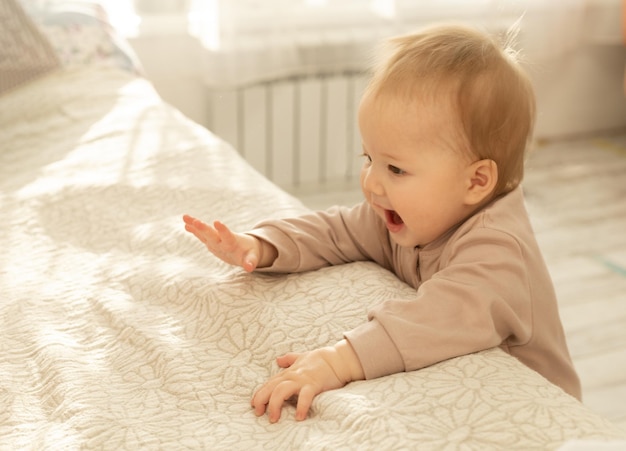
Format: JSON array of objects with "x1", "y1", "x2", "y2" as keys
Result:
[{"x1": 105, "y1": 0, "x2": 588, "y2": 86}]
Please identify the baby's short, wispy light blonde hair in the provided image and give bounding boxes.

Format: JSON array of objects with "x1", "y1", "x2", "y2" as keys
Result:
[{"x1": 365, "y1": 24, "x2": 535, "y2": 195}]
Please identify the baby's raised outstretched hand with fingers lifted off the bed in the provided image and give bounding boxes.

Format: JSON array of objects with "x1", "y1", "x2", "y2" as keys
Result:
[{"x1": 183, "y1": 215, "x2": 278, "y2": 272}]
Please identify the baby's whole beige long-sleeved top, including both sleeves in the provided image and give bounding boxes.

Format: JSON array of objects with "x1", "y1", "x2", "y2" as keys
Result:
[{"x1": 250, "y1": 188, "x2": 581, "y2": 399}]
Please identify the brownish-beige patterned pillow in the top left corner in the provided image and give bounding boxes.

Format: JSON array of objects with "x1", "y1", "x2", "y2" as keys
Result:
[{"x1": 0, "y1": 0, "x2": 60, "y2": 95}]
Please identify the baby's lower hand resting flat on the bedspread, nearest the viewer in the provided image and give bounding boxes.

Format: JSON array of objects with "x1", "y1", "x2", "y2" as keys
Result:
[{"x1": 252, "y1": 340, "x2": 365, "y2": 423}]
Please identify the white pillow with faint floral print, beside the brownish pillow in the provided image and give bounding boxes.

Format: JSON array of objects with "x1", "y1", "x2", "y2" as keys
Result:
[{"x1": 21, "y1": 0, "x2": 143, "y2": 74}]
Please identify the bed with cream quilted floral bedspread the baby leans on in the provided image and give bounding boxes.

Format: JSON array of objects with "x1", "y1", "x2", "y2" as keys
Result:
[{"x1": 0, "y1": 0, "x2": 624, "y2": 450}]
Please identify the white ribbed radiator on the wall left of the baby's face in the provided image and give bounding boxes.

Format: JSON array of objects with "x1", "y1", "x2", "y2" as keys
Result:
[{"x1": 210, "y1": 72, "x2": 366, "y2": 188}]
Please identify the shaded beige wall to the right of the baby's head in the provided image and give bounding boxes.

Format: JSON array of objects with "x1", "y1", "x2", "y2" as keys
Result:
[{"x1": 529, "y1": 0, "x2": 626, "y2": 138}]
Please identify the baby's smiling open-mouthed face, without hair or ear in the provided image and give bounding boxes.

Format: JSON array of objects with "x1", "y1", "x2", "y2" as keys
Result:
[{"x1": 359, "y1": 96, "x2": 472, "y2": 247}]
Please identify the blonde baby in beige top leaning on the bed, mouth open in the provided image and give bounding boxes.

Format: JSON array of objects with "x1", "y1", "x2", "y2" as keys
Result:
[{"x1": 184, "y1": 25, "x2": 581, "y2": 422}]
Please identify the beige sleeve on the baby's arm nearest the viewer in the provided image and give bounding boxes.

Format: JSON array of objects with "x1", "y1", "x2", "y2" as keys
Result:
[{"x1": 346, "y1": 229, "x2": 532, "y2": 378}]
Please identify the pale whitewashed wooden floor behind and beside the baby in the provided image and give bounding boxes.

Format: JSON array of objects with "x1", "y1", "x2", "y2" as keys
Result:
[{"x1": 296, "y1": 131, "x2": 626, "y2": 430}]
